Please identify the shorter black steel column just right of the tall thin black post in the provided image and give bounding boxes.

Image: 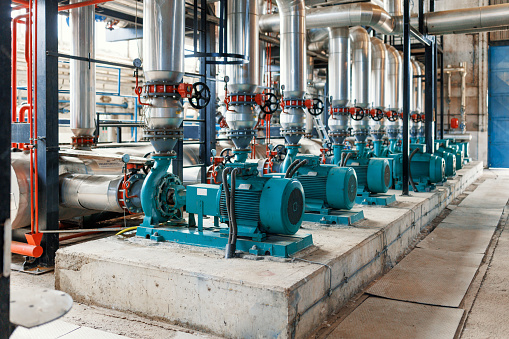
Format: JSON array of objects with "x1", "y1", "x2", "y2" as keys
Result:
[{"x1": 424, "y1": 37, "x2": 436, "y2": 154}]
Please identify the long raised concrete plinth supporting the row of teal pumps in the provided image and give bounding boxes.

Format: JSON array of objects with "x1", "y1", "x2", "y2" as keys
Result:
[{"x1": 55, "y1": 162, "x2": 482, "y2": 338}]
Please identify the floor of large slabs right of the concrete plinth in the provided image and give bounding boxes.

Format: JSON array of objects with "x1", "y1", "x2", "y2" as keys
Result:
[{"x1": 325, "y1": 170, "x2": 509, "y2": 338}]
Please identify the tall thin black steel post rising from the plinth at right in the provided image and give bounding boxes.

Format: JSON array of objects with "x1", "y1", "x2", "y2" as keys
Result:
[{"x1": 402, "y1": 0, "x2": 412, "y2": 195}]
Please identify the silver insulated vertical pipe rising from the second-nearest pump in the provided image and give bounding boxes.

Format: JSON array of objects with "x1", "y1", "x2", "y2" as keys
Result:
[{"x1": 224, "y1": 0, "x2": 260, "y2": 149}]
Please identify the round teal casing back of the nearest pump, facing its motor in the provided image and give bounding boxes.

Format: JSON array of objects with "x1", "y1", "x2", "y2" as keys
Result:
[{"x1": 155, "y1": 173, "x2": 185, "y2": 219}]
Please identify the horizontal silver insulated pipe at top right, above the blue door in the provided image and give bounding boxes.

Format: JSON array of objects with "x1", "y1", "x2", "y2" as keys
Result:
[{"x1": 425, "y1": 4, "x2": 509, "y2": 35}]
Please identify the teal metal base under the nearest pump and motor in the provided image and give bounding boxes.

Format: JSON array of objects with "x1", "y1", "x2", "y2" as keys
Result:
[{"x1": 136, "y1": 225, "x2": 313, "y2": 258}]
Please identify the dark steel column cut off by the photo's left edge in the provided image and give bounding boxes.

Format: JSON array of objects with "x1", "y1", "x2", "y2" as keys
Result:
[{"x1": 0, "y1": 1, "x2": 11, "y2": 339}]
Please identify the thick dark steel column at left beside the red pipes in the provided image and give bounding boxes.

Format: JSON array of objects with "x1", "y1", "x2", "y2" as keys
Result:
[{"x1": 35, "y1": 0, "x2": 59, "y2": 266}]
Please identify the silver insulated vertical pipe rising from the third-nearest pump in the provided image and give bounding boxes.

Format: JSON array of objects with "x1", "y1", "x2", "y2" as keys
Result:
[{"x1": 277, "y1": 0, "x2": 307, "y2": 145}]
